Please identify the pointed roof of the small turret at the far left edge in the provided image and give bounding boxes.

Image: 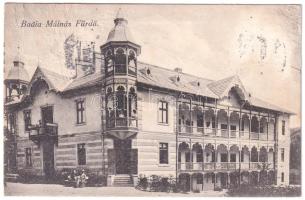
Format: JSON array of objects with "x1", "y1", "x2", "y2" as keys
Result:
[{"x1": 5, "y1": 61, "x2": 30, "y2": 82}]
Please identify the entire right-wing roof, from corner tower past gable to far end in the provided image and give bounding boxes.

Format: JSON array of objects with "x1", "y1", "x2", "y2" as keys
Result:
[{"x1": 138, "y1": 62, "x2": 293, "y2": 114}]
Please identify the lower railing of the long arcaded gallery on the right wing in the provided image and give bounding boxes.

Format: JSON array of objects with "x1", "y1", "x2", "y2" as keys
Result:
[{"x1": 178, "y1": 162, "x2": 274, "y2": 171}]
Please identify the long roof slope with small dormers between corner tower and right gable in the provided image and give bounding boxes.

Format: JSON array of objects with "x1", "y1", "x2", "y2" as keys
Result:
[{"x1": 138, "y1": 62, "x2": 217, "y2": 98}]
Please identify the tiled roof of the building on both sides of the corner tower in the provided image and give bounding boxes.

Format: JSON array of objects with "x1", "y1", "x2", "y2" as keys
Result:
[{"x1": 13, "y1": 62, "x2": 293, "y2": 114}]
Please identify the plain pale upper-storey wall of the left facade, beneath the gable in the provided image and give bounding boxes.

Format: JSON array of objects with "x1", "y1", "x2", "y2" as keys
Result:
[{"x1": 17, "y1": 82, "x2": 101, "y2": 137}]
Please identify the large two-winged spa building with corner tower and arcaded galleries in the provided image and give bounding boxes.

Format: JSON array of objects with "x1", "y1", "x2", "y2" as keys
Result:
[{"x1": 5, "y1": 11, "x2": 291, "y2": 190}]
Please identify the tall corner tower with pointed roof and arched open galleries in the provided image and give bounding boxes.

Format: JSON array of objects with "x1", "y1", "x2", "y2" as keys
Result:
[{"x1": 101, "y1": 9, "x2": 141, "y2": 140}]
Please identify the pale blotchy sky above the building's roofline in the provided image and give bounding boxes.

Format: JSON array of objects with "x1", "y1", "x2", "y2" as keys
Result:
[{"x1": 4, "y1": 4, "x2": 301, "y2": 127}]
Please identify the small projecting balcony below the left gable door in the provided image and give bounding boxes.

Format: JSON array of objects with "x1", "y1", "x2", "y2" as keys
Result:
[{"x1": 29, "y1": 123, "x2": 58, "y2": 143}]
